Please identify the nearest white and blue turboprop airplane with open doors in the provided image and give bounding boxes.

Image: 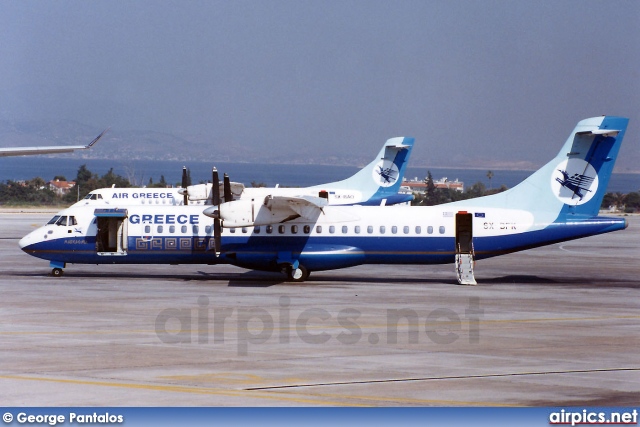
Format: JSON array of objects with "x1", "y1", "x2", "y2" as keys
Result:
[{"x1": 19, "y1": 116, "x2": 628, "y2": 284}]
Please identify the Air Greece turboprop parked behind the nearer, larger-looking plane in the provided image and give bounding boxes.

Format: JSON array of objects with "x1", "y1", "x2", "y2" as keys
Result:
[{"x1": 76, "y1": 137, "x2": 414, "y2": 207}]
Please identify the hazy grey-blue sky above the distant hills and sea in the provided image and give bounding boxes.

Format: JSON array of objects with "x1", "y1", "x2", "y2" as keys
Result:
[{"x1": 0, "y1": 0, "x2": 640, "y2": 172}]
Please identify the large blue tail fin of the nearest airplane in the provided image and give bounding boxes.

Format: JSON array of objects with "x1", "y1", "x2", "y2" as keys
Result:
[{"x1": 458, "y1": 116, "x2": 629, "y2": 222}]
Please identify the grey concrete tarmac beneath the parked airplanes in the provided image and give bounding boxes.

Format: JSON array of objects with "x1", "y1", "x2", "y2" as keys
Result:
[{"x1": 0, "y1": 212, "x2": 640, "y2": 406}]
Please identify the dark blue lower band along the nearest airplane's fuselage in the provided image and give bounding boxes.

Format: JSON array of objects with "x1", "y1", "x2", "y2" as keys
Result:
[{"x1": 23, "y1": 218, "x2": 625, "y2": 270}]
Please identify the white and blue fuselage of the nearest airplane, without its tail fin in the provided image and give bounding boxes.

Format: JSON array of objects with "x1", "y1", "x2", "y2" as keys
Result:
[{"x1": 20, "y1": 204, "x2": 626, "y2": 271}]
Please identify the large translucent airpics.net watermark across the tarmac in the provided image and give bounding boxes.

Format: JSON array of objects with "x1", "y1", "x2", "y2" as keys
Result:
[{"x1": 155, "y1": 295, "x2": 484, "y2": 356}]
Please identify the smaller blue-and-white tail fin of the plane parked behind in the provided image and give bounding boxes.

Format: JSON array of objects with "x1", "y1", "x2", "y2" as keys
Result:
[{"x1": 315, "y1": 137, "x2": 414, "y2": 205}]
